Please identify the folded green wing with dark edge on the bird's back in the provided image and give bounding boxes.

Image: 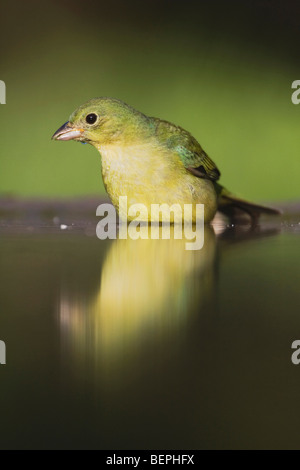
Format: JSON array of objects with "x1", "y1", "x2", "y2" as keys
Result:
[{"x1": 151, "y1": 118, "x2": 221, "y2": 181}]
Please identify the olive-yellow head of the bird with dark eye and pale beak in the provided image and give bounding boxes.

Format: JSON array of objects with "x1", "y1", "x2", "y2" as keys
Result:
[{"x1": 52, "y1": 98, "x2": 148, "y2": 147}]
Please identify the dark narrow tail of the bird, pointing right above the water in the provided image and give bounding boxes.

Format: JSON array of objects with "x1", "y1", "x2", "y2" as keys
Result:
[{"x1": 215, "y1": 183, "x2": 280, "y2": 223}]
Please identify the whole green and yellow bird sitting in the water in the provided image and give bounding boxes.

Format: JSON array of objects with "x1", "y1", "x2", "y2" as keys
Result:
[{"x1": 52, "y1": 97, "x2": 278, "y2": 222}]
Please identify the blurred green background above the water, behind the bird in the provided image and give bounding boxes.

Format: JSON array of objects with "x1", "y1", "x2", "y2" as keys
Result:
[{"x1": 0, "y1": 0, "x2": 300, "y2": 201}]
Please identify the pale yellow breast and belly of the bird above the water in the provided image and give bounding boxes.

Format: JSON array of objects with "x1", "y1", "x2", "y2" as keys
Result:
[{"x1": 98, "y1": 144, "x2": 216, "y2": 220}]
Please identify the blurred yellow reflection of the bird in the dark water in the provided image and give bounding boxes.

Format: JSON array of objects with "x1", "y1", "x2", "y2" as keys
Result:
[{"x1": 59, "y1": 227, "x2": 216, "y2": 369}]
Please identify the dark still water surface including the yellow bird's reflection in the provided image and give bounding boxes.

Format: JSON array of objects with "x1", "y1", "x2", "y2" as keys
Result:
[{"x1": 0, "y1": 200, "x2": 300, "y2": 449}]
